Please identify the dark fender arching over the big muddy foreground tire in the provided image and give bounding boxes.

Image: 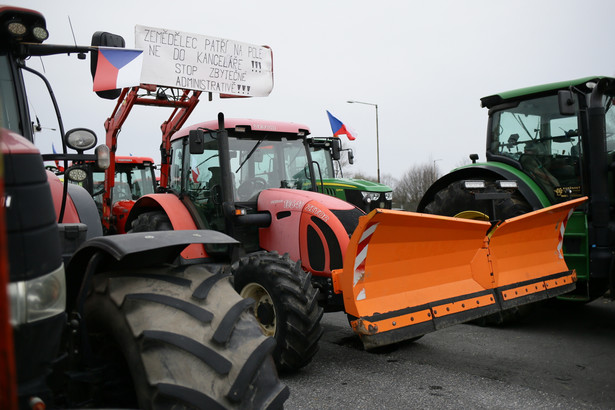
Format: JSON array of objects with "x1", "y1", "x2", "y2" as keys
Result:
[{"x1": 66, "y1": 230, "x2": 238, "y2": 312}]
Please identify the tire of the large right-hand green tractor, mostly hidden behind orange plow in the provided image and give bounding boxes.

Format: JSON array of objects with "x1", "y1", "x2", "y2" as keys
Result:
[{"x1": 423, "y1": 181, "x2": 533, "y2": 326}]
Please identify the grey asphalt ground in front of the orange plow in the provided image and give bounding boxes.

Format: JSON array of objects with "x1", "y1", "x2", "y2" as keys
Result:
[{"x1": 281, "y1": 298, "x2": 615, "y2": 409}]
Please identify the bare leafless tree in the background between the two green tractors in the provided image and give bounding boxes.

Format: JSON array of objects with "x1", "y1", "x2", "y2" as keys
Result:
[{"x1": 393, "y1": 160, "x2": 438, "y2": 211}]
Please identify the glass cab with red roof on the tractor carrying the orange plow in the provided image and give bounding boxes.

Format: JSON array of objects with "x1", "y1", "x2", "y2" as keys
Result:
[{"x1": 167, "y1": 115, "x2": 315, "y2": 251}]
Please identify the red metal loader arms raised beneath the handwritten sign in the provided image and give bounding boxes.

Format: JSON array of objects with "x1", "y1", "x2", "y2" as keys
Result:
[{"x1": 102, "y1": 84, "x2": 201, "y2": 229}]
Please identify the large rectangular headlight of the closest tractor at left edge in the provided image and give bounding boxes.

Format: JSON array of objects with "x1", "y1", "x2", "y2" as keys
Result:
[{"x1": 9, "y1": 265, "x2": 66, "y2": 326}]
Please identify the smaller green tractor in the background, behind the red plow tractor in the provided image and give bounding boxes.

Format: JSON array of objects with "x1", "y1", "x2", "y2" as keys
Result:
[{"x1": 308, "y1": 137, "x2": 393, "y2": 213}]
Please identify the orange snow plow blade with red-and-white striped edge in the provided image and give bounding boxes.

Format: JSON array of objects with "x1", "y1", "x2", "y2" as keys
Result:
[{"x1": 333, "y1": 198, "x2": 586, "y2": 349}]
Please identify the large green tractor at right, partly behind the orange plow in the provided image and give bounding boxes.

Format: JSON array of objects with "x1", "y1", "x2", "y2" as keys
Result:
[{"x1": 418, "y1": 77, "x2": 615, "y2": 302}]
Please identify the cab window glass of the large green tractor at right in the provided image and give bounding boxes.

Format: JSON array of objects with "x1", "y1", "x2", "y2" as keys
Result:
[{"x1": 488, "y1": 95, "x2": 582, "y2": 202}]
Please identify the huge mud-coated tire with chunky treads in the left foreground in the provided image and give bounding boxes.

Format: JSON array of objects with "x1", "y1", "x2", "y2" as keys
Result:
[{"x1": 84, "y1": 265, "x2": 289, "y2": 409}]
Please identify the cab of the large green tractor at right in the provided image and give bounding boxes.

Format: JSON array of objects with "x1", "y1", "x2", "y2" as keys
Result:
[{"x1": 482, "y1": 80, "x2": 615, "y2": 203}]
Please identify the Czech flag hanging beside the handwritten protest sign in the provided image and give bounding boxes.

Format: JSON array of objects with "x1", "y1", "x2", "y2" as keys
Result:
[{"x1": 94, "y1": 47, "x2": 143, "y2": 91}]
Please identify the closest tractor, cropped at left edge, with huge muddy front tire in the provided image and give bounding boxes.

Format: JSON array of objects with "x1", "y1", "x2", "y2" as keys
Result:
[{"x1": 0, "y1": 6, "x2": 289, "y2": 409}]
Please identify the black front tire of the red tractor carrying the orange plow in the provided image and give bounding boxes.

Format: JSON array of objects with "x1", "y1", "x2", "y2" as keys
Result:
[{"x1": 231, "y1": 251, "x2": 323, "y2": 371}]
